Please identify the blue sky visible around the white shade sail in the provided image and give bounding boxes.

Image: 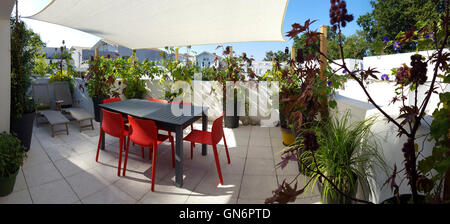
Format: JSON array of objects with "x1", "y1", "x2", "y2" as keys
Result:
[{"x1": 13, "y1": 0, "x2": 372, "y2": 60}]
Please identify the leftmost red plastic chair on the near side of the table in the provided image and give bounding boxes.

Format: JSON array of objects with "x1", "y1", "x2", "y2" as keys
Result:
[{"x1": 95, "y1": 109, "x2": 128, "y2": 176}]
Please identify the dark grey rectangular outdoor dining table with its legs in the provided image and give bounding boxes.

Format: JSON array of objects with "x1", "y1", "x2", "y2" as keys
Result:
[{"x1": 99, "y1": 99, "x2": 208, "y2": 187}]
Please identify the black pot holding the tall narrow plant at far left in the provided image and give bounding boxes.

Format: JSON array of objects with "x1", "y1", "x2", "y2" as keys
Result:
[{"x1": 9, "y1": 112, "x2": 36, "y2": 152}]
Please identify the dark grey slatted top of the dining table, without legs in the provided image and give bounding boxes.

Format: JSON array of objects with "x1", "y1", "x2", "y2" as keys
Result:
[{"x1": 99, "y1": 99, "x2": 208, "y2": 125}]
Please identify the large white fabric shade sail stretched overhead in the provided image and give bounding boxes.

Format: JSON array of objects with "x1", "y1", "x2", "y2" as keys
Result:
[{"x1": 29, "y1": 0, "x2": 289, "y2": 49}]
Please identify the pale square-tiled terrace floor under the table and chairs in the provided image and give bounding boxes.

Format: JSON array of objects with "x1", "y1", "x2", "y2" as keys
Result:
[{"x1": 0, "y1": 121, "x2": 320, "y2": 204}]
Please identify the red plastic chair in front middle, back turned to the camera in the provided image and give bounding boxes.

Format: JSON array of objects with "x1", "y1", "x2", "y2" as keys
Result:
[{"x1": 123, "y1": 116, "x2": 175, "y2": 191}]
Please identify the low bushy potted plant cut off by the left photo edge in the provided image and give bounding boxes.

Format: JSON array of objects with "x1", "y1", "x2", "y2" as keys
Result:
[{"x1": 0, "y1": 132, "x2": 27, "y2": 197}]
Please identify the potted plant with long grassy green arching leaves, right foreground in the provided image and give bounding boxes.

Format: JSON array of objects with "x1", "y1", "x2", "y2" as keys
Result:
[{"x1": 302, "y1": 113, "x2": 387, "y2": 204}]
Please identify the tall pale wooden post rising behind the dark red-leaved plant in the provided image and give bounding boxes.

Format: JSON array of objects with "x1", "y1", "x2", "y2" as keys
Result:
[{"x1": 320, "y1": 25, "x2": 329, "y2": 120}]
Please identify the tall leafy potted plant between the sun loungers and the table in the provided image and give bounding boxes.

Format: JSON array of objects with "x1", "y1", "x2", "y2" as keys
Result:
[{"x1": 79, "y1": 55, "x2": 120, "y2": 122}]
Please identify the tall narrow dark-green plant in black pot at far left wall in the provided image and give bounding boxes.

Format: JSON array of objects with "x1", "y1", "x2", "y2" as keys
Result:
[{"x1": 10, "y1": 19, "x2": 44, "y2": 151}]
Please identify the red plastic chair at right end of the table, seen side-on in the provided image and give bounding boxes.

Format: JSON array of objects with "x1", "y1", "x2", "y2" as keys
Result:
[{"x1": 184, "y1": 116, "x2": 231, "y2": 185}]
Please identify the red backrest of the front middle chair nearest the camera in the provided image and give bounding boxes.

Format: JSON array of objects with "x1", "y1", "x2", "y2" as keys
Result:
[{"x1": 128, "y1": 116, "x2": 158, "y2": 146}]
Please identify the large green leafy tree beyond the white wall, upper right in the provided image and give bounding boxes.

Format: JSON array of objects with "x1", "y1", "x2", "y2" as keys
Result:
[{"x1": 356, "y1": 0, "x2": 445, "y2": 53}]
